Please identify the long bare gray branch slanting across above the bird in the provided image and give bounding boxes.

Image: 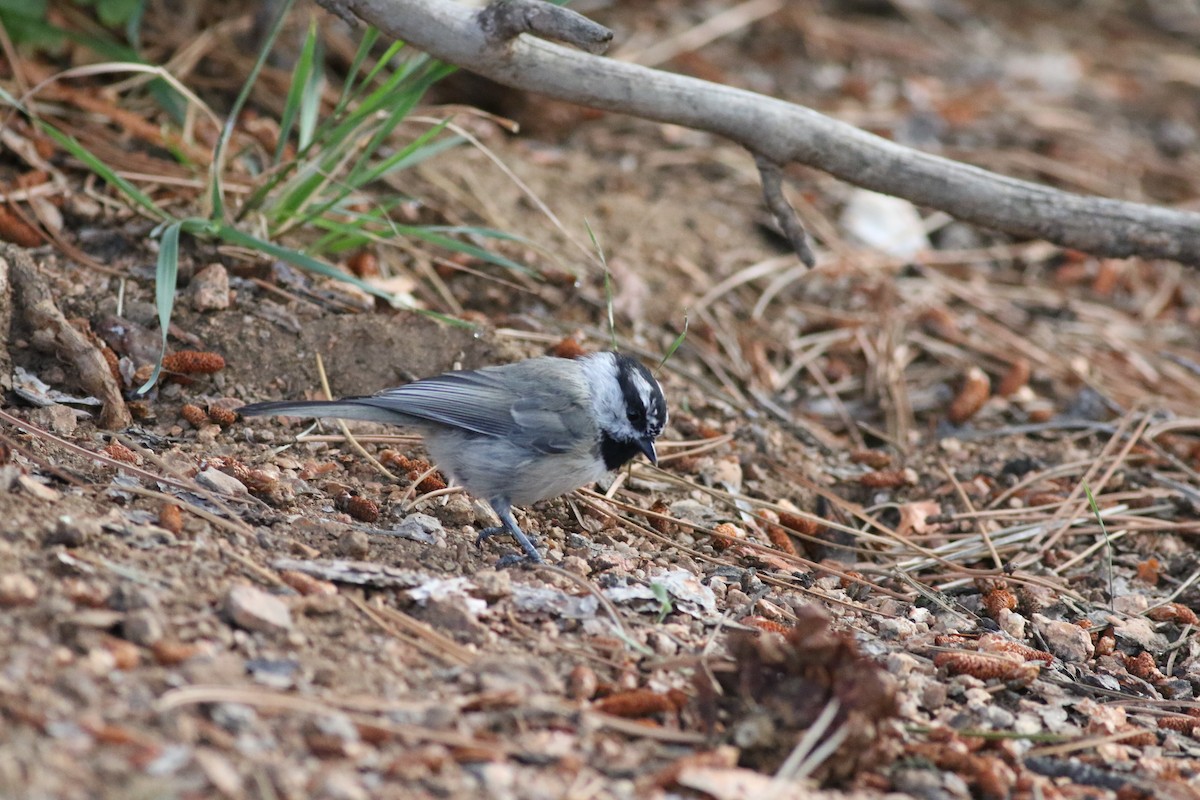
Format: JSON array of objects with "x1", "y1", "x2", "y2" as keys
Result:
[{"x1": 319, "y1": 0, "x2": 1200, "y2": 266}]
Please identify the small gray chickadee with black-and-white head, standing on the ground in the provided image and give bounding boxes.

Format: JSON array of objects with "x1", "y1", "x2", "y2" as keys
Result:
[{"x1": 238, "y1": 353, "x2": 667, "y2": 561}]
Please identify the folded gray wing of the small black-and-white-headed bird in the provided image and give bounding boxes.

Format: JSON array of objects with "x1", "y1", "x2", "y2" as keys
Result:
[{"x1": 355, "y1": 360, "x2": 590, "y2": 452}]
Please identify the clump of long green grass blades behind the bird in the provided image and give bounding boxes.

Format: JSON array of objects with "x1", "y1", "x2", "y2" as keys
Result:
[{"x1": 0, "y1": 2, "x2": 532, "y2": 392}]
